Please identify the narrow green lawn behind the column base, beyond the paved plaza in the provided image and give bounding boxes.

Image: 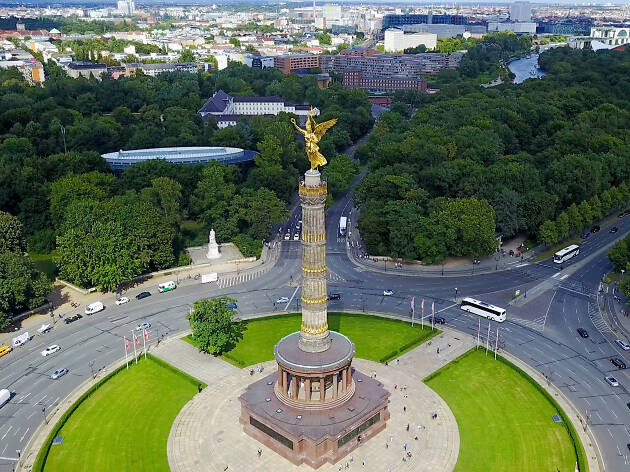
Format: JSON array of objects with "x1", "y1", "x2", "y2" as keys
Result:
[{"x1": 184, "y1": 313, "x2": 440, "y2": 367}]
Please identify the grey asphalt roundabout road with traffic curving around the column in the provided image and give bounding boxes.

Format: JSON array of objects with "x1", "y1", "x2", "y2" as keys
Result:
[{"x1": 0, "y1": 207, "x2": 630, "y2": 472}]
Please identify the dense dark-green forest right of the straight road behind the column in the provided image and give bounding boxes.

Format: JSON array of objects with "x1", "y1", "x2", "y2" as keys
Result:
[{"x1": 355, "y1": 45, "x2": 630, "y2": 263}]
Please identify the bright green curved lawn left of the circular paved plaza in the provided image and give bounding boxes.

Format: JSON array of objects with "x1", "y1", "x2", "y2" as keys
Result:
[{"x1": 44, "y1": 358, "x2": 197, "y2": 472}]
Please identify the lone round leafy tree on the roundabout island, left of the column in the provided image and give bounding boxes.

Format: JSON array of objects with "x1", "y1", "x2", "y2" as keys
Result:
[{"x1": 186, "y1": 297, "x2": 245, "y2": 356}]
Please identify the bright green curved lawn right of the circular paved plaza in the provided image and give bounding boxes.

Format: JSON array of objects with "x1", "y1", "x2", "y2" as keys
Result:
[{"x1": 426, "y1": 349, "x2": 579, "y2": 472}]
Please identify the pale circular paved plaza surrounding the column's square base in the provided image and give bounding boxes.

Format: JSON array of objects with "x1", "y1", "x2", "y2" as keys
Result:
[{"x1": 168, "y1": 359, "x2": 459, "y2": 472}]
